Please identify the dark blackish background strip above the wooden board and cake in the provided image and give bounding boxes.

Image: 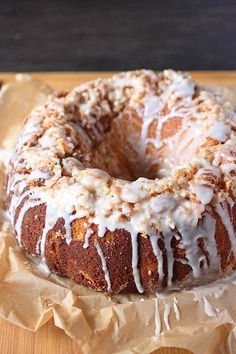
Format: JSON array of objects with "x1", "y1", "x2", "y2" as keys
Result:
[{"x1": 0, "y1": 0, "x2": 236, "y2": 71}]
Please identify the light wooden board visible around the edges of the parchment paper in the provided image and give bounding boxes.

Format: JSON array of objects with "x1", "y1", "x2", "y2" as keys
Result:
[{"x1": 0, "y1": 71, "x2": 236, "y2": 354}]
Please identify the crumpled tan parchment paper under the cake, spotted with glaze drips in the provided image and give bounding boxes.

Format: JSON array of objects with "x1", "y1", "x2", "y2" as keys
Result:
[{"x1": 0, "y1": 75, "x2": 236, "y2": 354}]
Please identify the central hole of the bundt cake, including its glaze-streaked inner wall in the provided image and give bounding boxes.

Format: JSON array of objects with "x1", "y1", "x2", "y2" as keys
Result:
[{"x1": 73, "y1": 85, "x2": 198, "y2": 181}]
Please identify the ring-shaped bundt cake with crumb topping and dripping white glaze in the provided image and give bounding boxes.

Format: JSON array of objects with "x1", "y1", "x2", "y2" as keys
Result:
[{"x1": 6, "y1": 70, "x2": 236, "y2": 293}]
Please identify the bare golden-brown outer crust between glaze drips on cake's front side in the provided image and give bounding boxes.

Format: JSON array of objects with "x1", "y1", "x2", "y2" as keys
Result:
[{"x1": 15, "y1": 205, "x2": 236, "y2": 293}]
